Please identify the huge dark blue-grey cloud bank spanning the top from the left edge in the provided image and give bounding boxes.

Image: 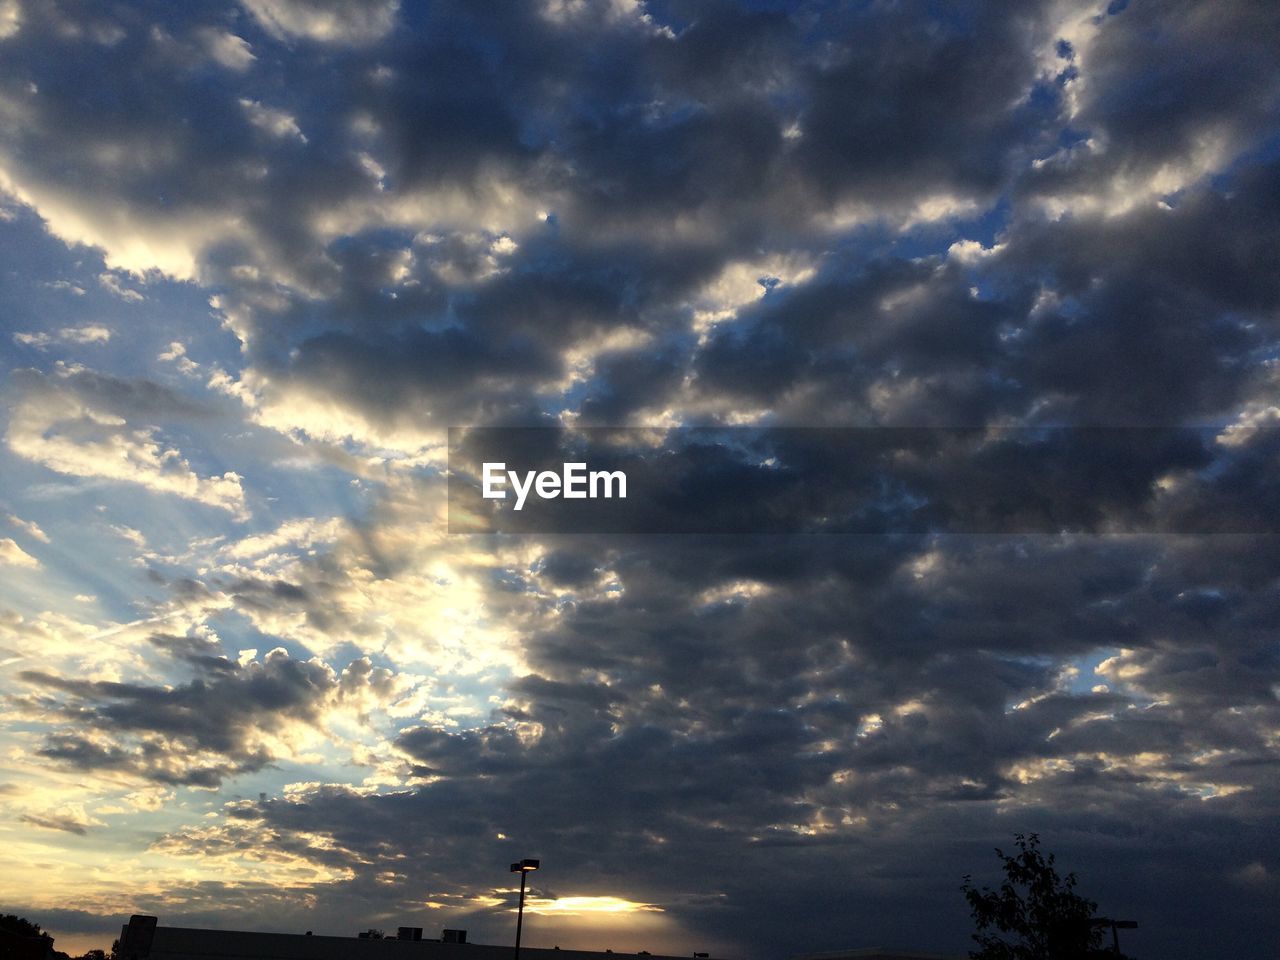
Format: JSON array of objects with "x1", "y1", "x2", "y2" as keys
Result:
[{"x1": 9, "y1": 5, "x2": 1047, "y2": 419}]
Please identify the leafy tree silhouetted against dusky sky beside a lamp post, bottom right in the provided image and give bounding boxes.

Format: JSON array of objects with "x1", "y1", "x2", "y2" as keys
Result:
[{"x1": 963, "y1": 833, "x2": 1123, "y2": 960}]
